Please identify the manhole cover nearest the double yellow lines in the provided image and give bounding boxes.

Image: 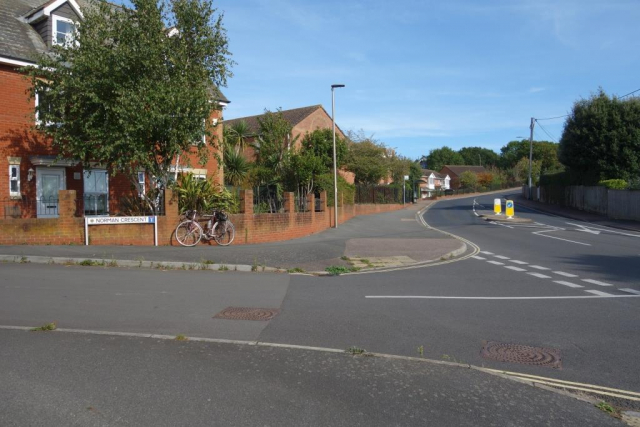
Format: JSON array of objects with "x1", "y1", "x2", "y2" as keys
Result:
[{"x1": 480, "y1": 341, "x2": 562, "y2": 369}]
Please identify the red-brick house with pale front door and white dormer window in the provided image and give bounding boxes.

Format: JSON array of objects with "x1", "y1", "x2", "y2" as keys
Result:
[{"x1": 0, "y1": 0, "x2": 229, "y2": 218}]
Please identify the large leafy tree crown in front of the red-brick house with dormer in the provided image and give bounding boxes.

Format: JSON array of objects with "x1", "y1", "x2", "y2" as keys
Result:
[{"x1": 25, "y1": 0, "x2": 232, "y2": 209}]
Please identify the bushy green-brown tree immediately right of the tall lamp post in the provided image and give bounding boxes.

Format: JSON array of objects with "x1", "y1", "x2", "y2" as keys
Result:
[{"x1": 345, "y1": 132, "x2": 389, "y2": 185}]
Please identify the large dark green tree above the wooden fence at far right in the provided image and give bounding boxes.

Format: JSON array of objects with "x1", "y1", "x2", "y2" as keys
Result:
[{"x1": 560, "y1": 89, "x2": 640, "y2": 184}]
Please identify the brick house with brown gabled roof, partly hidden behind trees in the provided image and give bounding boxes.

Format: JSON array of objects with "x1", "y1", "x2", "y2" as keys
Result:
[{"x1": 224, "y1": 105, "x2": 355, "y2": 184}]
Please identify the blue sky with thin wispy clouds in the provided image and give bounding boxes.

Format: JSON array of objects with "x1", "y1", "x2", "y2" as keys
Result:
[{"x1": 122, "y1": 0, "x2": 640, "y2": 158}]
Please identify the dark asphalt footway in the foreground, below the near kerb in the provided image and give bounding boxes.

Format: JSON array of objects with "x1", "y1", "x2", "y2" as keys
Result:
[{"x1": 0, "y1": 330, "x2": 621, "y2": 427}]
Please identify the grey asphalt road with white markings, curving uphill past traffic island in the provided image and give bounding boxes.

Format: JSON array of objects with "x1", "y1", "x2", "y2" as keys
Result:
[{"x1": 0, "y1": 196, "x2": 640, "y2": 425}]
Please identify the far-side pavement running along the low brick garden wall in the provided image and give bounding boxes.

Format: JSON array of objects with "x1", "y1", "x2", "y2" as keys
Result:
[{"x1": 0, "y1": 202, "x2": 463, "y2": 271}]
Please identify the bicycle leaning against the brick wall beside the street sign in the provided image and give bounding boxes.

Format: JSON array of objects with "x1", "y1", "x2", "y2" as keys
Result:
[{"x1": 175, "y1": 210, "x2": 236, "y2": 246}]
